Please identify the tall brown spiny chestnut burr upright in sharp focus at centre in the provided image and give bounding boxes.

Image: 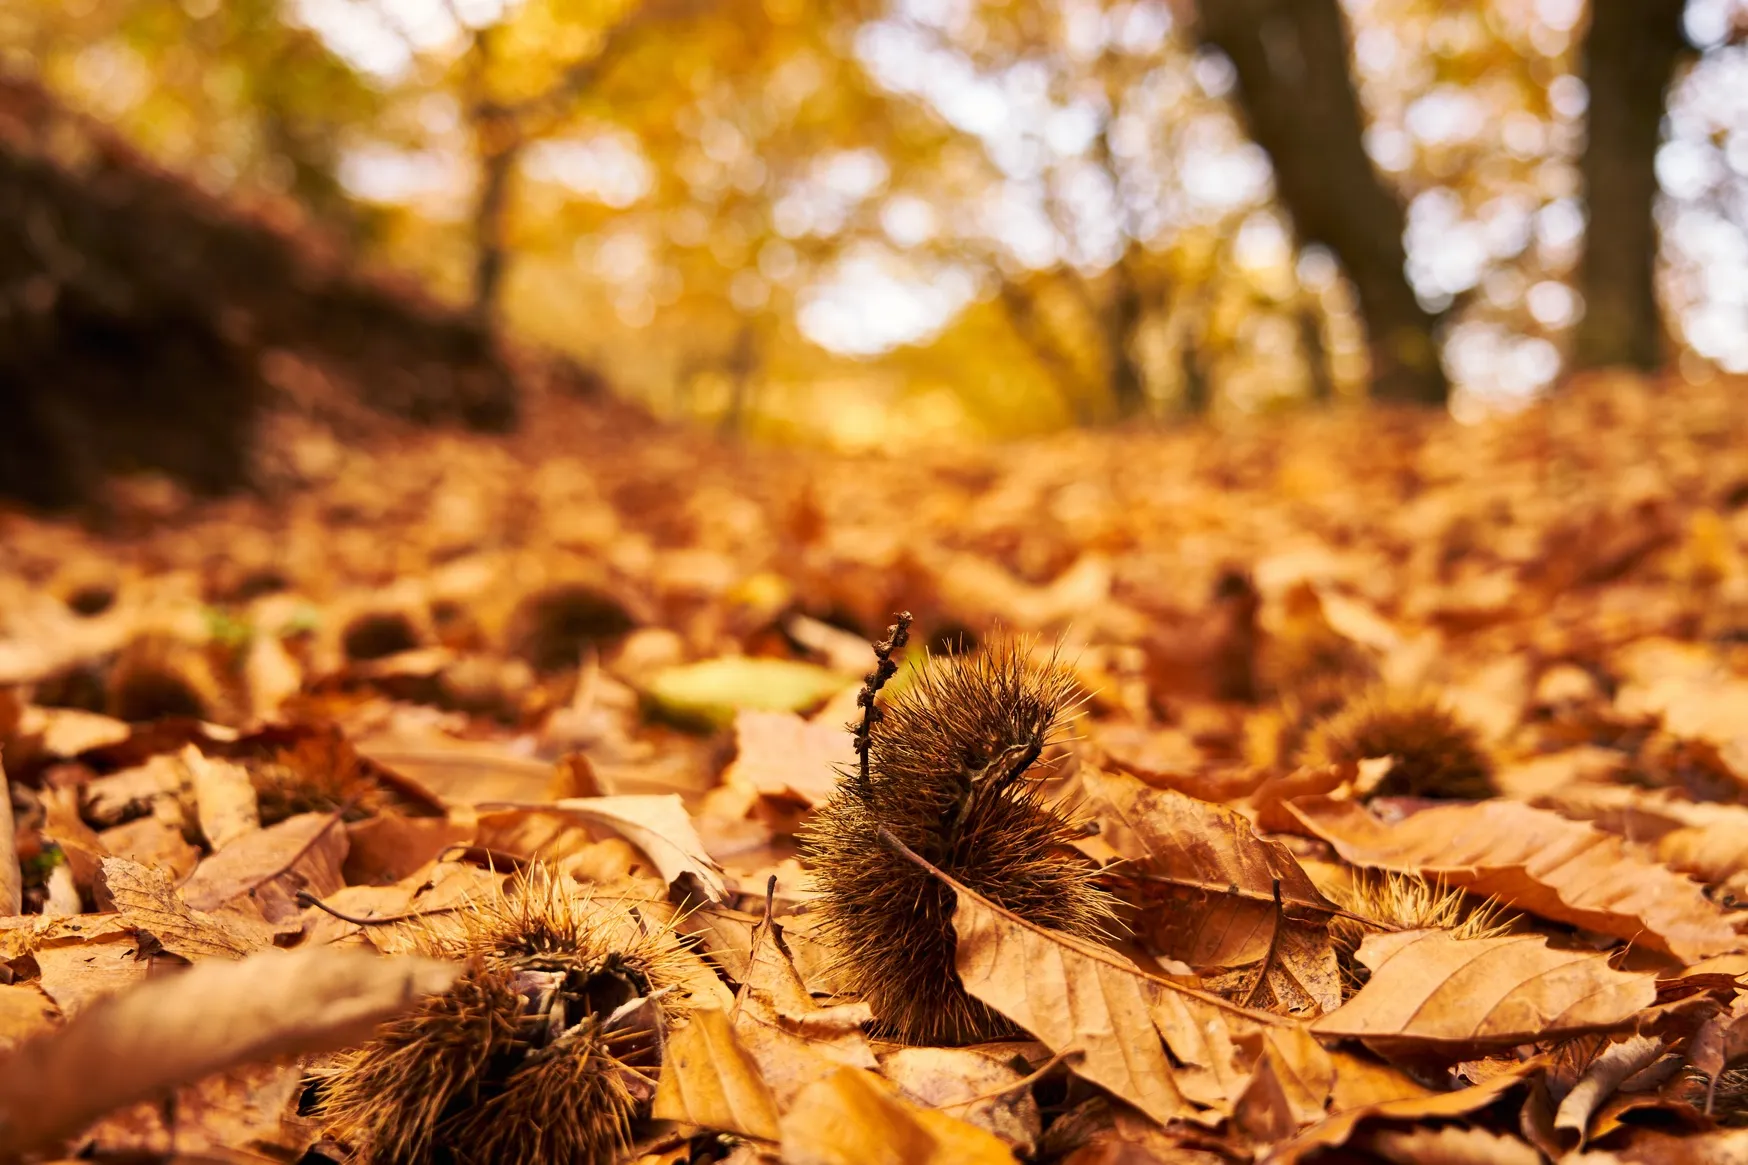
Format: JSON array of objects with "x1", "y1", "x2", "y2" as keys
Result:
[{"x1": 802, "y1": 637, "x2": 1112, "y2": 1044}]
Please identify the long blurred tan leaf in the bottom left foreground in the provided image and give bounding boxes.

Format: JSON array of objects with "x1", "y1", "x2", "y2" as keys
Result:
[{"x1": 0, "y1": 948, "x2": 456, "y2": 1156}]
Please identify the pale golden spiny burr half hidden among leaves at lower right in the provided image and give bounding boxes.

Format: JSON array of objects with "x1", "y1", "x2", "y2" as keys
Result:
[{"x1": 1328, "y1": 869, "x2": 1517, "y2": 994}]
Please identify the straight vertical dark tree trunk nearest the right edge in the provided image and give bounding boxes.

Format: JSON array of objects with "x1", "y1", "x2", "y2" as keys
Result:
[{"x1": 1571, "y1": 0, "x2": 1689, "y2": 371}]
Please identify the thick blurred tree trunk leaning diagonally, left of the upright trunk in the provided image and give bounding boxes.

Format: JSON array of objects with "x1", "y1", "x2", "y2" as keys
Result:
[{"x1": 1197, "y1": 0, "x2": 1447, "y2": 404}]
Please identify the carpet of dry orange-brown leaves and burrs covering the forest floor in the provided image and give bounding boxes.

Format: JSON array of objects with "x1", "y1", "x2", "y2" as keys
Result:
[{"x1": 0, "y1": 369, "x2": 1748, "y2": 1165}]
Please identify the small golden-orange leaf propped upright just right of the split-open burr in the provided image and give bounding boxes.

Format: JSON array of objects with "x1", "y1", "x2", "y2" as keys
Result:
[{"x1": 650, "y1": 1008, "x2": 781, "y2": 1141}]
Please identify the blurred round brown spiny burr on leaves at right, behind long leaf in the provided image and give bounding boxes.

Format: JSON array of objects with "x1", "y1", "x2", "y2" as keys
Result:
[{"x1": 1299, "y1": 689, "x2": 1498, "y2": 801}]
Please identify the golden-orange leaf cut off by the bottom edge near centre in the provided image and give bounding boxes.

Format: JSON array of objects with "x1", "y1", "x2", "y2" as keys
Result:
[{"x1": 783, "y1": 1067, "x2": 1014, "y2": 1165}]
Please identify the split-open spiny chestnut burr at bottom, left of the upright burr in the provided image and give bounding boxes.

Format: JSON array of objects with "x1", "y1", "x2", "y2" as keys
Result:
[{"x1": 316, "y1": 862, "x2": 689, "y2": 1165}]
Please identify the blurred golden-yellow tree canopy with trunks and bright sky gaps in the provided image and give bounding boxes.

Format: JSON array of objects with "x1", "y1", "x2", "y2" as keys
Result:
[{"x1": 10, "y1": 0, "x2": 1748, "y2": 443}]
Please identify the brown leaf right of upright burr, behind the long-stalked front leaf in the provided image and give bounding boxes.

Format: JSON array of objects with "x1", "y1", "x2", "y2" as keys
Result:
[{"x1": 1080, "y1": 766, "x2": 1341, "y2": 1011}]
